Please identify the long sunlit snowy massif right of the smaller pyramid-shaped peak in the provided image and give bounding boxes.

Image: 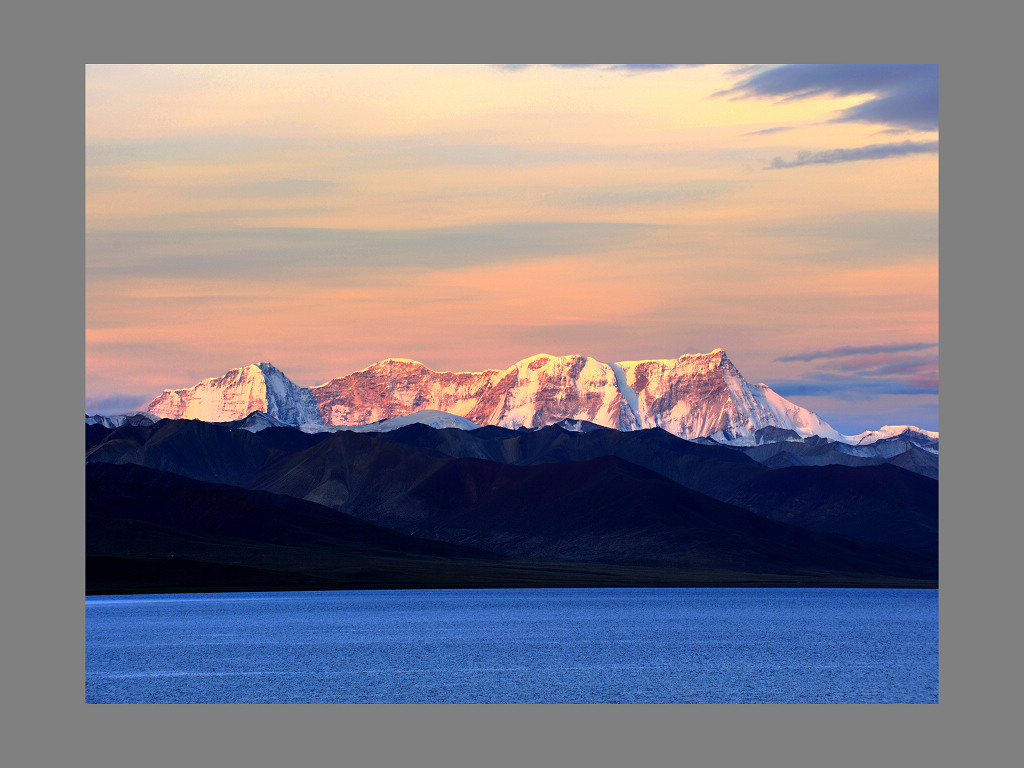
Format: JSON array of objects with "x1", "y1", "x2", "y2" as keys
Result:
[{"x1": 310, "y1": 349, "x2": 842, "y2": 441}]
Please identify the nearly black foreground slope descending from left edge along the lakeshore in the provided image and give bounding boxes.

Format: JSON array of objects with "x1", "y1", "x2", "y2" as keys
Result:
[{"x1": 86, "y1": 463, "x2": 929, "y2": 594}]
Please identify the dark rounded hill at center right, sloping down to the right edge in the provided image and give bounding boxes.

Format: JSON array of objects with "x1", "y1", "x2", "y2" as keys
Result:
[{"x1": 333, "y1": 457, "x2": 934, "y2": 578}]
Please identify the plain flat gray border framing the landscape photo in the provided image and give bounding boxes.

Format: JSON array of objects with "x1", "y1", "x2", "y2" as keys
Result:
[{"x1": 0, "y1": 0, "x2": 1007, "y2": 767}]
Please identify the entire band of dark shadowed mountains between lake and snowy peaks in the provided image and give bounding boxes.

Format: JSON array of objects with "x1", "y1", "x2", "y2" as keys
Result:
[{"x1": 86, "y1": 419, "x2": 938, "y2": 592}]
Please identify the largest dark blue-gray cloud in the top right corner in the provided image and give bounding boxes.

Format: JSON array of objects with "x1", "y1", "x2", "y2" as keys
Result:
[{"x1": 715, "y1": 65, "x2": 939, "y2": 131}]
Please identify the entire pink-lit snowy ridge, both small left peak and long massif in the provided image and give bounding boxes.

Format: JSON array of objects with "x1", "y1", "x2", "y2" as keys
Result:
[{"x1": 147, "y1": 349, "x2": 864, "y2": 442}]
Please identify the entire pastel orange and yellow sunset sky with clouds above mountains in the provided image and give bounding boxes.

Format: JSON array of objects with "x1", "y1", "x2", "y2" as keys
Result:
[{"x1": 85, "y1": 65, "x2": 939, "y2": 434}]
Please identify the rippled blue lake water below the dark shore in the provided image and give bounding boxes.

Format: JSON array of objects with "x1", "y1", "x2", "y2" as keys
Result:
[{"x1": 85, "y1": 589, "x2": 939, "y2": 703}]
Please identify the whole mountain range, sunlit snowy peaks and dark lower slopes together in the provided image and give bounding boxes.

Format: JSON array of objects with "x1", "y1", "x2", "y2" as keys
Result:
[{"x1": 85, "y1": 349, "x2": 938, "y2": 594}]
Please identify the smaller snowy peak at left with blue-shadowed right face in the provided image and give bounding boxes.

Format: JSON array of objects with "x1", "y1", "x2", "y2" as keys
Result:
[{"x1": 147, "y1": 362, "x2": 322, "y2": 424}]
